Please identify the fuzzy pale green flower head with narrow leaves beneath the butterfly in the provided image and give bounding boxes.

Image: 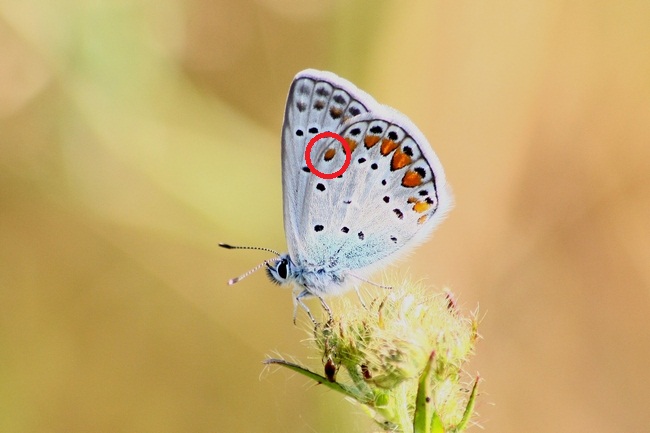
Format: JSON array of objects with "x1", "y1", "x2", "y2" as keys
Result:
[{"x1": 267, "y1": 282, "x2": 478, "y2": 433}]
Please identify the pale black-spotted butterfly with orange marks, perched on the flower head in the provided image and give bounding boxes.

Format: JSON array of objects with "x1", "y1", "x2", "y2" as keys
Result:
[{"x1": 220, "y1": 69, "x2": 453, "y2": 322}]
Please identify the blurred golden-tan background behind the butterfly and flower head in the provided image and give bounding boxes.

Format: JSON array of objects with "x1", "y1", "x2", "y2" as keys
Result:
[{"x1": 0, "y1": 0, "x2": 650, "y2": 433}]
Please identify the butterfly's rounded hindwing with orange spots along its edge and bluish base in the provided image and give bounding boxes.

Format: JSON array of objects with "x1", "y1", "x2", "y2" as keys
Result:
[{"x1": 302, "y1": 107, "x2": 452, "y2": 273}]
